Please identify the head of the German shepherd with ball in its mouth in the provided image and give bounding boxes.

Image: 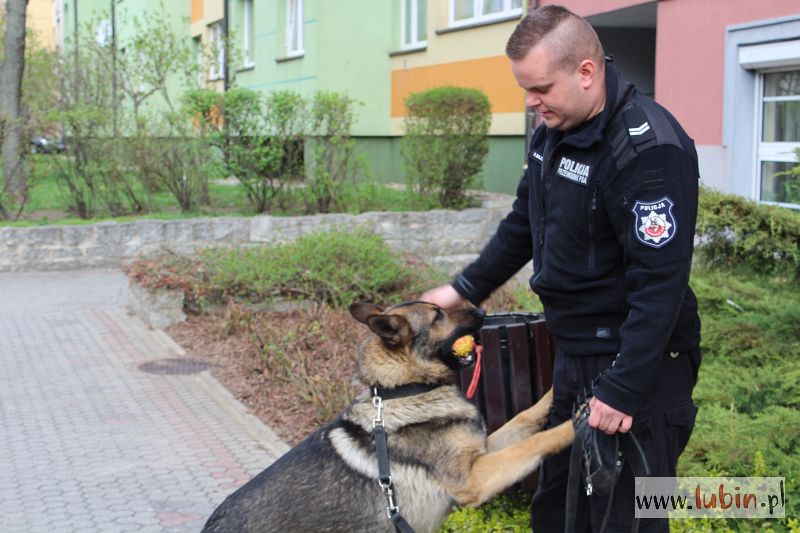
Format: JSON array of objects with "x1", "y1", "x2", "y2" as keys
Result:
[{"x1": 350, "y1": 302, "x2": 485, "y2": 386}]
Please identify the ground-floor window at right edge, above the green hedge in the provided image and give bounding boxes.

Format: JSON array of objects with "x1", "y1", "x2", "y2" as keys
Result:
[{"x1": 758, "y1": 70, "x2": 800, "y2": 208}]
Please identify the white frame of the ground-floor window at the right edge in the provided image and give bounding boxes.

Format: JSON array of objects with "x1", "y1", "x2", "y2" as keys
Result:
[{"x1": 753, "y1": 63, "x2": 800, "y2": 209}]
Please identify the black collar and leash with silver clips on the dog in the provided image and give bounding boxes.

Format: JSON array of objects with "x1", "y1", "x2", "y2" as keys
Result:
[{"x1": 371, "y1": 383, "x2": 441, "y2": 533}]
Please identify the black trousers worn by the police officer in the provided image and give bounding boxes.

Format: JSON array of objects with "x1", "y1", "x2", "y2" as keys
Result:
[{"x1": 531, "y1": 349, "x2": 700, "y2": 533}]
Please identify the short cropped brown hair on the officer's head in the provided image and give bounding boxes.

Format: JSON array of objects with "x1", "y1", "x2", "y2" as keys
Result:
[{"x1": 506, "y1": 5, "x2": 604, "y2": 70}]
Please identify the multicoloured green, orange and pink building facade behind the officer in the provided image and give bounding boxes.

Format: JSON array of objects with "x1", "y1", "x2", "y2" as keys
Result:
[{"x1": 55, "y1": 0, "x2": 800, "y2": 204}]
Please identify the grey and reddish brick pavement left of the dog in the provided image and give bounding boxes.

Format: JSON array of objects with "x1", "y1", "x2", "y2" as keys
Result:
[{"x1": 0, "y1": 270, "x2": 286, "y2": 533}]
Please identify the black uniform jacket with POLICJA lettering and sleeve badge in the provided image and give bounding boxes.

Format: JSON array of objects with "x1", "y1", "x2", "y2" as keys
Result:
[{"x1": 453, "y1": 63, "x2": 700, "y2": 415}]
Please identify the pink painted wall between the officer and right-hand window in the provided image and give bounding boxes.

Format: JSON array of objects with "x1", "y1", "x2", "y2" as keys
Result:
[{"x1": 531, "y1": 0, "x2": 800, "y2": 145}]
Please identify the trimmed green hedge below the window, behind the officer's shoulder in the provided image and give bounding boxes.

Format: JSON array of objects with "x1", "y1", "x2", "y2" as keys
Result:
[{"x1": 697, "y1": 190, "x2": 800, "y2": 280}]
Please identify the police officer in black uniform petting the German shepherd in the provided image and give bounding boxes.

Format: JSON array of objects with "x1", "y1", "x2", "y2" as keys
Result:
[{"x1": 422, "y1": 6, "x2": 700, "y2": 533}]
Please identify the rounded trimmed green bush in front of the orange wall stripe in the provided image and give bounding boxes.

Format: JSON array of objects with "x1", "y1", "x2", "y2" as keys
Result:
[{"x1": 401, "y1": 87, "x2": 492, "y2": 208}]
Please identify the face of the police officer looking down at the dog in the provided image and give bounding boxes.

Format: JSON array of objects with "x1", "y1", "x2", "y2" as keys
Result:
[{"x1": 511, "y1": 43, "x2": 602, "y2": 131}]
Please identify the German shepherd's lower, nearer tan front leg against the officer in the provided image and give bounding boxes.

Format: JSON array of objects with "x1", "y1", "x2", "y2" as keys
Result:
[{"x1": 453, "y1": 420, "x2": 575, "y2": 507}]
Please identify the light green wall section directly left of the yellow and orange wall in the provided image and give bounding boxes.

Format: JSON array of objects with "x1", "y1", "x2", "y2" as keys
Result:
[{"x1": 230, "y1": 0, "x2": 398, "y2": 135}]
